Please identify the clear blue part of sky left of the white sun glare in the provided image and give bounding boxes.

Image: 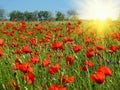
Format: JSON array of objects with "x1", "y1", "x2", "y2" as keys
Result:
[{"x1": 0, "y1": 0, "x2": 74, "y2": 12}]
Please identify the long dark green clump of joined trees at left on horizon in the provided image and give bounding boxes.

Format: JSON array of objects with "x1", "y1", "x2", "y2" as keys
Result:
[{"x1": 9, "y1": 11, "x2": 53, "y2": 21}]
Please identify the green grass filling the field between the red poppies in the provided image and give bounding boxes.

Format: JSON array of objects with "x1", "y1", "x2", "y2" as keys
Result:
[{"x1": 0, "y1": 21, "x2": 120, "y2": 90}]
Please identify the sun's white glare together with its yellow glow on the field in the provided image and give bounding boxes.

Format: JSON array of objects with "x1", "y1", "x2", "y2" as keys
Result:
[{"x1": 73, "y1": 0, "x2": 120, "y2": 36}]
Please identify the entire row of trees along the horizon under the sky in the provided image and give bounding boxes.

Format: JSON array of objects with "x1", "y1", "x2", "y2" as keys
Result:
[{"x1": 0, "y1": 9, "x2": 77, "y2": 21}]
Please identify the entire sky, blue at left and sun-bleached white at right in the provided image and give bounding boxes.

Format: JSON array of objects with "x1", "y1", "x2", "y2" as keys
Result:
[{"x1": 0, "y1": 0, "x2": 120, "y2": 19}]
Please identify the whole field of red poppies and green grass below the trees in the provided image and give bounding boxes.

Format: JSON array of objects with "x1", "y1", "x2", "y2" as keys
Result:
[{"x1": 0, "y1": 20, "x2": 120, "y2": 90}]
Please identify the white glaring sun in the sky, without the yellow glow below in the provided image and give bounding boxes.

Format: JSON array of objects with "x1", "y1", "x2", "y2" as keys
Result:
[{"x1": 75, "y1": 0, "x2": 120, "y2": 20}]
